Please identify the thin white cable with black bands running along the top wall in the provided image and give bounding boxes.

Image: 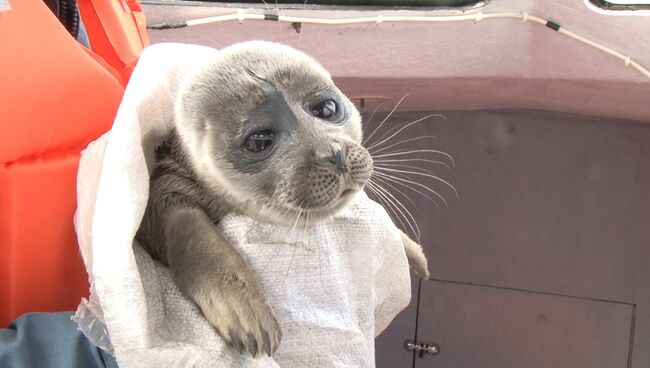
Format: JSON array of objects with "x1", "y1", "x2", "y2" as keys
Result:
[{"x1": 166, "y1": 9, "x2": 650, "y2": 78}]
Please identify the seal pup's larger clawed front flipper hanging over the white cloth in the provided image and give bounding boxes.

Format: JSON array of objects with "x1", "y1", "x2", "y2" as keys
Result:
[{"x1": 165, "y1": 208, "x2": 282, "y2": 357}]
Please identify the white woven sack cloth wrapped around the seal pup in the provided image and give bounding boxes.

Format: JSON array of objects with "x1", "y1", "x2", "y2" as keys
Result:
[{"x1": 74, "y1": 44, "x2": 411, "y2": 368}]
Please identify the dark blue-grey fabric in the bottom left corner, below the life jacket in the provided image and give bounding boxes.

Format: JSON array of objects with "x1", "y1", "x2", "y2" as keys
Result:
[{"x1": 0, "y1": 312, "x2": 117, "y2": 368}]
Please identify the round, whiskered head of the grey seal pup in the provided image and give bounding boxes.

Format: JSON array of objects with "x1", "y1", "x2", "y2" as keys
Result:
[{"x1": 176, "y1": 41, "x2": 372, "y2": 224}]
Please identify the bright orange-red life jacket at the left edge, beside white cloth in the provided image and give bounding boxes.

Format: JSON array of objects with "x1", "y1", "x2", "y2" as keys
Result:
[{"x1": 0, "y1": 0, "x2": 147, "y2": 326}]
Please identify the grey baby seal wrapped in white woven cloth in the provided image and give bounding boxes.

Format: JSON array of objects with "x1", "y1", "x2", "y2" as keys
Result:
[{"x1": 136, "y1": 41, "x2": 428, "y2": 356}]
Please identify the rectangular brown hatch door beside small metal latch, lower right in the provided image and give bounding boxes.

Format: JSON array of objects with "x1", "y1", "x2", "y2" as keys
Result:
[{"x1": 415, "y1": 281, "x2": 634, "y2": 368}]
